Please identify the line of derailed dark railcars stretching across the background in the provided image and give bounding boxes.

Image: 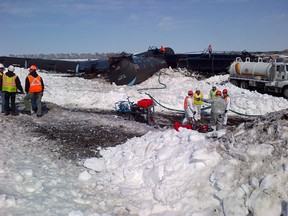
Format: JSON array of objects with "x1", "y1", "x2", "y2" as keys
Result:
[{"x1": 0, "y1": 46, "x2": 256, "y2": 86}]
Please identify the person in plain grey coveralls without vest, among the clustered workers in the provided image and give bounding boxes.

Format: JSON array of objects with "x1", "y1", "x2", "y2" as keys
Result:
[{"x1": 203, "y1": 90, "x2": 227, "y2": 130}]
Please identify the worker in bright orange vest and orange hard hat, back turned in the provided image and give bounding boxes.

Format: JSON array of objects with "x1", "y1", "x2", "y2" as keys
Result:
[{"x1": 24, "y1": 65, "x2": 44, "y2": 117}]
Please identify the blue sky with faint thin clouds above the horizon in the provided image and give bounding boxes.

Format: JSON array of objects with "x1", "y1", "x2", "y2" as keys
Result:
[{"x1": 0, "y1": 0, "x2": 288, "y2": 55}]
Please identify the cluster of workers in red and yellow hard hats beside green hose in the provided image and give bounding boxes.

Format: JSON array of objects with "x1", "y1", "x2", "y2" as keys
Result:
[{"x1": 182, "y1": 85, "x2": 231, "y2": 130}]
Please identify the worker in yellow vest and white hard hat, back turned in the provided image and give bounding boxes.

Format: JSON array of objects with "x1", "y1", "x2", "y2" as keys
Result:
[{"x1": 0, "y1": 65, "x2": 24, "y2": 115}]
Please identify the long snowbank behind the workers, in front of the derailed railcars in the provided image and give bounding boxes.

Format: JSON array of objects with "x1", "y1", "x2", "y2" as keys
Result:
[{"x1": 16, "y1": 69, "x2": 288, "y2": 115}]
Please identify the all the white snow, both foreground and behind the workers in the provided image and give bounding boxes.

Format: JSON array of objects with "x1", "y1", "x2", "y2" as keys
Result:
[{"x1": 0, "y1": 68, "x2": 288, "y2": 216}]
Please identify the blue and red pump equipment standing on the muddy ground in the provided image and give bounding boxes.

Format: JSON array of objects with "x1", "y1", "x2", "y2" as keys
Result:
[{"x1": 115, "y1": 97, "x2": 155, "y2": 125}]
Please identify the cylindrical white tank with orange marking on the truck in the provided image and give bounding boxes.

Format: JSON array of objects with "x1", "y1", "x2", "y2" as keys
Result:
[{"x1": 229, "y1": 58, "x2": 275, "y2": 80}]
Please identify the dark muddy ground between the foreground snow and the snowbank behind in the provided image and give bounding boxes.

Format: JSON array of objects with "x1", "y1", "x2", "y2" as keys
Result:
[{"x1": 8, "y1": 103, "x2": 252, "y2": 160}]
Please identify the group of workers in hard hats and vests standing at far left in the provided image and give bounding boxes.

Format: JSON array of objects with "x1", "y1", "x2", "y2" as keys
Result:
[{"x1": 0, "y1": 63, "x2": 44, "y2": 117}]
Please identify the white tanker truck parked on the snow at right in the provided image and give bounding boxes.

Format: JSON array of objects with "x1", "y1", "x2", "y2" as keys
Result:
[{"x1": 229, "y1": 58, "x2": 288, "y2": 98}]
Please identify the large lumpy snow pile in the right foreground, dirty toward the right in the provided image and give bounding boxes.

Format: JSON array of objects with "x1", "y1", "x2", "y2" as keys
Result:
[{"x1": 84, "y1": 110, "x2": 288, "y2": 215}]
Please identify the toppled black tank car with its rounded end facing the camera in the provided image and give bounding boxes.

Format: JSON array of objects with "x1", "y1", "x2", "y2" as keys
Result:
[{"x1": 109, "y1": 53, "x2": 167, "y2": 86}]
